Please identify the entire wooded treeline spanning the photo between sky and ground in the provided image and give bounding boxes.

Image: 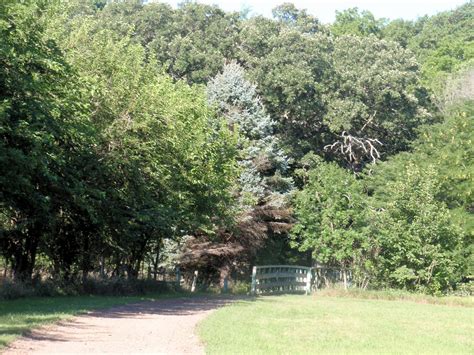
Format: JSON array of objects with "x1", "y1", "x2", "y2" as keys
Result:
[{"x1": 0, "y1": 0, "x2": 474, "y2": 292}]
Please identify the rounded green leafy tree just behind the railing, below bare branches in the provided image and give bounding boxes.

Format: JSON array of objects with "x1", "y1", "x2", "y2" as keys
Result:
[{"x1": 292, "y1": 157, "x2": 373, "y2": 271}]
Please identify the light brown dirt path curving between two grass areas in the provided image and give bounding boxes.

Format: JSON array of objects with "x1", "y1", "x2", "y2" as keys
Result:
[{"x1": 4, "y1": 298, "x2": 231, "y2": 355}]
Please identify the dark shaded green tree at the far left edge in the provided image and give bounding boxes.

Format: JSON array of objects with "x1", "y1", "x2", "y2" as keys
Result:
[{"x1": 0, "y1": 3, "x2": 99, "y2": 278}]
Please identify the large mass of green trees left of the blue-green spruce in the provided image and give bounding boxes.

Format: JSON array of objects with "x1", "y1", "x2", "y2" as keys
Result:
[{"x1": 0, "y1": 1, "x2": 236, "y2": 280}]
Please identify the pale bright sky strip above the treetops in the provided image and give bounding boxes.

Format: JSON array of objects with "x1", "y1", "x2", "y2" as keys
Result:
[{"x1": 158, "y1": 0, "x2": 468, "y2": 23}]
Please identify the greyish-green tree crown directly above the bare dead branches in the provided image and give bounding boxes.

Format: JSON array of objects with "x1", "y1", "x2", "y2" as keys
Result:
[{"x1": 324, "y1": 35, "x2": 430, "y2": 170}]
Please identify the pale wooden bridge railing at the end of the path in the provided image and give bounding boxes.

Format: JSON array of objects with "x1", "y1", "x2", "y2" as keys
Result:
[{"x1": 252, "y1": 265, "x2": 312, "y2": 295}]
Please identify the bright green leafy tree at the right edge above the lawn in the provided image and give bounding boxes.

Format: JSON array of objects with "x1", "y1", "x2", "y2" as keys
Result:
[{"x1": 369, "y1": 102, "x2": 474, "y2": 292}]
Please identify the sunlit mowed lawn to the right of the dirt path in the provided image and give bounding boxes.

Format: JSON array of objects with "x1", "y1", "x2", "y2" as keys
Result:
[{"x1": 198, "y1": 295, "x2": 474, "y2": 354}]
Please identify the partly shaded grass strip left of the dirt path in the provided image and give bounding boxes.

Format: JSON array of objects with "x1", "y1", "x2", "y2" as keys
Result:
[{"x1": 0, "y1": 296, "x2": 145, "y2": 349}]
